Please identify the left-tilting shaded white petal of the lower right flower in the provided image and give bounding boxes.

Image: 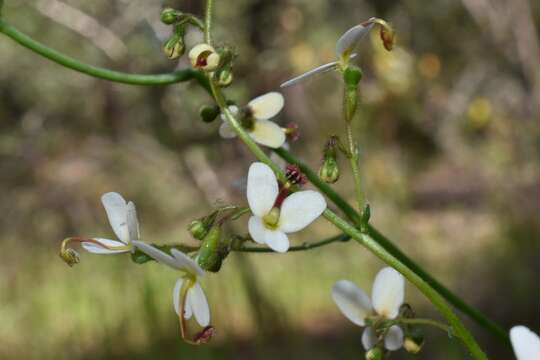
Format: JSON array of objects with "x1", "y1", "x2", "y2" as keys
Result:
[{"x1": 332, "y1": 280, "x2": 372, "y2": 326}]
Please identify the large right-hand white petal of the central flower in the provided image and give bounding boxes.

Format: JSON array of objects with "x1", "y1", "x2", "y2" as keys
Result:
[{"x1": 278, "y1": 190, "x2": 326, "y2": 233}]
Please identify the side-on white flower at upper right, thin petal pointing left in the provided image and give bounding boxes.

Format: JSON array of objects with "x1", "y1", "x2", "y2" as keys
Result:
[{"x1": 280, "y1": 19, "x2": 373, "y2": 88}]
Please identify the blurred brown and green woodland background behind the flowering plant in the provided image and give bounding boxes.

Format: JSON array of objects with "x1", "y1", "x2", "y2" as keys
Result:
[{"x1": 0, "y1": 0, "x2": 540, "y2": 359}]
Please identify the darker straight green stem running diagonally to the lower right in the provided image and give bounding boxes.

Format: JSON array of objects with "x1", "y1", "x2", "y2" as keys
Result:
[{"x1": 274, "y1": 148, "x2": 511, "y2": 347}]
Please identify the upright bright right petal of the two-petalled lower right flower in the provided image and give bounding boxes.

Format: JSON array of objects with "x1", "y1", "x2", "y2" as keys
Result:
[{"x1": 371, "y1": 267, "x2": 405, "y2": 319}]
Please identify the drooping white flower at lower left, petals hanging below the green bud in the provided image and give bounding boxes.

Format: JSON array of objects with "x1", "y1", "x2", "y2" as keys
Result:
[{"x1": 133, "y1": 241, "x2": 210, "y2": 327}]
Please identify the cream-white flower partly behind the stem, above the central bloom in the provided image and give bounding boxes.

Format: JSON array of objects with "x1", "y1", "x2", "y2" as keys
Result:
[{"x1": 219, "y1": 92, "x2": 285, "y2": 149}]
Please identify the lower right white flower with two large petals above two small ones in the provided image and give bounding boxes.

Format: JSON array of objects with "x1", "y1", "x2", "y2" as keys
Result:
[{"x1": 332, "y1": 267, "x2": 405, "y2": 351}]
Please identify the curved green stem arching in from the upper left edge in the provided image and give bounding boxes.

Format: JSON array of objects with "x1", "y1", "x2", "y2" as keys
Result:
[{"x1": 0, "y1": 20, "x2": 210, "y2": 91}]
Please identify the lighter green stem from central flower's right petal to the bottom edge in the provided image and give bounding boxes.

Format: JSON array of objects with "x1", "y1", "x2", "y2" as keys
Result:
[{"x1": 323, "y1": 209, "x2": 487, "y2": 359}]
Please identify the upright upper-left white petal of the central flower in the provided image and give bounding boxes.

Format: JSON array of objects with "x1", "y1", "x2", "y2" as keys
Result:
[{"x1": 247, "y1": 162, "x2": 279, "y2": 217}]
